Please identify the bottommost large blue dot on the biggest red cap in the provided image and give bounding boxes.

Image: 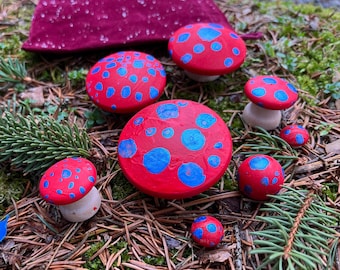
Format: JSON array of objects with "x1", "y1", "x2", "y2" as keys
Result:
[{"x1": 177, "y1": 162, "x2": 206, "y2": 188}]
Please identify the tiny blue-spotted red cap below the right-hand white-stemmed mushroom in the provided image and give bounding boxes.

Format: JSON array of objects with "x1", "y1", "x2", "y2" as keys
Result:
[{"x1": 280, "y1": 125, "x2": 309, "y2": 147}]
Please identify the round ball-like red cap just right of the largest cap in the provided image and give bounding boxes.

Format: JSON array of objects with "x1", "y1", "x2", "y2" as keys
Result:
[{"x1": 238, "y1": 154, "x2": 284, "y2": 201}]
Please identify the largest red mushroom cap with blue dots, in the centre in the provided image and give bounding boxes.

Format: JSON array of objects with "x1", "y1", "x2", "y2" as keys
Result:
[{"x1": 118, "y1": 100, "x2": 232, "y2": 199}]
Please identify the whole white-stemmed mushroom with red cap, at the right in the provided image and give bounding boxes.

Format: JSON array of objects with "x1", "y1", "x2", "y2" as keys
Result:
[{"x1": 242, "y1": 76, "x2": 298, "y2": 130}]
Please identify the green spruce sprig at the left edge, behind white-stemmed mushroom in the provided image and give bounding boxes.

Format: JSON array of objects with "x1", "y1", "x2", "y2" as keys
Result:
[{"x1": 0, "y1": 111, "x2": 91, "y2": 173}]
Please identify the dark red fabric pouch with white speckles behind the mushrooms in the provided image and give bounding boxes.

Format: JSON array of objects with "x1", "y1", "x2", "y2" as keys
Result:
[{"x1": 22, "y1": 0, "x2": 260, "y2": 53}]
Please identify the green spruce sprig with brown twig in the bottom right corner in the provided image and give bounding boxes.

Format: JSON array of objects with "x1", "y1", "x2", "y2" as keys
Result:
[{"x1": 250, "y1": 187, "x2": 340, "y2": 270}]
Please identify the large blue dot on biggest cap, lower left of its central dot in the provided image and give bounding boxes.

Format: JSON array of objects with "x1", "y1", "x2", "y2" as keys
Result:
[{"x1": 143, "y1": 147, "x2": 171, "y2": 174}]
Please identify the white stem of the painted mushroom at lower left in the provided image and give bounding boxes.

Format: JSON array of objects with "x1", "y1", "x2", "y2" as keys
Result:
[{"x1": 59, "y1": 187, "x2": 101, "y2": 222}]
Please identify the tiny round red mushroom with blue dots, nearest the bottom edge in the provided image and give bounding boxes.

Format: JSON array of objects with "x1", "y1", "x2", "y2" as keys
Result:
[{"x1": 190, "y1": 216, "x2": 224, "y2": 248}]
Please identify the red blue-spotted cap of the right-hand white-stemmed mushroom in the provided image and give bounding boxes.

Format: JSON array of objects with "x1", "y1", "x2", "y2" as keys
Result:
[{"x1": 244, "y1": 76, "x2": 298, "y2": 110}]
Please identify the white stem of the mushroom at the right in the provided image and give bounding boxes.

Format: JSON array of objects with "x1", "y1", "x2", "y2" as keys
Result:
[{"x1": 242, "y1": 102, "x2": 281, "y2": 130}]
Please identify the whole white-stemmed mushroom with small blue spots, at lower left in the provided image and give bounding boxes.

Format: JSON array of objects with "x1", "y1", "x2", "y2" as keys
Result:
[{"x1": 39, "y1": 157, "x2": 101, "y2": 222}]
